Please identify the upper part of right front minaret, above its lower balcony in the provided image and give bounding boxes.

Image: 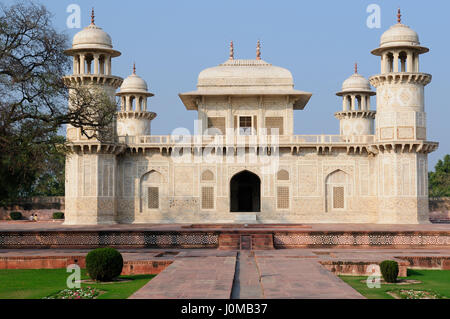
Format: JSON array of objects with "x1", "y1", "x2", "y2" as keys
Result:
[{"x1": 370, "y1": 9, "x2": 431, "y2": 141}]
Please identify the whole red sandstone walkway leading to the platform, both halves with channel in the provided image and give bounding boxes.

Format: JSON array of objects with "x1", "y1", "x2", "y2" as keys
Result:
[{"x1": 131, "y1": 251, "x2": 363, "y2": 299}]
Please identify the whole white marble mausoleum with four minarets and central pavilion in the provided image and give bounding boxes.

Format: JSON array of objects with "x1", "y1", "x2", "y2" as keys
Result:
[{"x1": 64, "y1": 10, "x2": 438, "y2": 225}]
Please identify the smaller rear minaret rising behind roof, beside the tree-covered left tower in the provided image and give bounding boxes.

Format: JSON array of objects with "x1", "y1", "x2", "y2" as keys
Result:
[{"x1": 116, "y1": 64, "x2": 156, "y2": 136}]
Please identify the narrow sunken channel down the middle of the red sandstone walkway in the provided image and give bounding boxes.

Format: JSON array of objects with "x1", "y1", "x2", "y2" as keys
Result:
[{"x1": 231, "y1": 251, "x2": 263, "y2": 299}]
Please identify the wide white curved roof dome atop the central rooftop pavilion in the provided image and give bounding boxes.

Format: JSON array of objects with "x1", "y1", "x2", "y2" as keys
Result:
[{"x1": 197, "y1": 59, "x2": 294, "y2": 89}]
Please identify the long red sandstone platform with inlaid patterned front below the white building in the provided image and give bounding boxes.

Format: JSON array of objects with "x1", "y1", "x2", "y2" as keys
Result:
[{"x1": 0, "y1": 222, "x2": 450, "y2": 250}]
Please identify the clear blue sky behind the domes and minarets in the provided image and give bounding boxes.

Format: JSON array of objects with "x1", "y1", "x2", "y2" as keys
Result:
[{"x1": 6, "y1": 0, "x2": 450, "y2": 170}]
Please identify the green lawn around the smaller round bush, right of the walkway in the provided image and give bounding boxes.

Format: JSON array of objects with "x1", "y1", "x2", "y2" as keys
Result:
[{"x1": 339, "y1": 269, "x2": 450, "y2": 299}]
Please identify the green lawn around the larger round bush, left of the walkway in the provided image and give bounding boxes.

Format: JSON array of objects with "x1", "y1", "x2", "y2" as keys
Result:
[{"x1": 0, "y1": 269, "x2": 155, "y2": 299}]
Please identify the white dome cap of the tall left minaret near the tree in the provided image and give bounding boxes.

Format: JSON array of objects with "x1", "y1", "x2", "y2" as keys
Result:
[{"x1": 72, "y1": 24, "x2": 112, "y2": 49}]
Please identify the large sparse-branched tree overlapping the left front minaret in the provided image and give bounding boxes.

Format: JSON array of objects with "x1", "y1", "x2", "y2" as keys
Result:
[{"x1": 0, "y1": 2, "x2": 117, "y2": 204}]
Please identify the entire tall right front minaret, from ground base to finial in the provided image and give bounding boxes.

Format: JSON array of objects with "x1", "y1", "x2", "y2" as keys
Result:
[{"x1": 370, "y1": 9, "x2": 438, "y2": 224}]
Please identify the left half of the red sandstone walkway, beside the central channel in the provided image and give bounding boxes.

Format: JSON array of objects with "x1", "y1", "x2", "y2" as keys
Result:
[{"x1": 130, "y1": 257, "x2": 236, "y2": 299}]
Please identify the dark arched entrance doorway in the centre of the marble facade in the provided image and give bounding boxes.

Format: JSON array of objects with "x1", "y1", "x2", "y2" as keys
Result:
[{"x1": 230, "y1": 171, "x2": 261, "y2": 212}]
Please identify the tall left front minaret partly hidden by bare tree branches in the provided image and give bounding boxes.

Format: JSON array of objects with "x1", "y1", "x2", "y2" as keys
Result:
[{"x1": 63, "y1": 10, "x2": 124, "y2": 225}]
